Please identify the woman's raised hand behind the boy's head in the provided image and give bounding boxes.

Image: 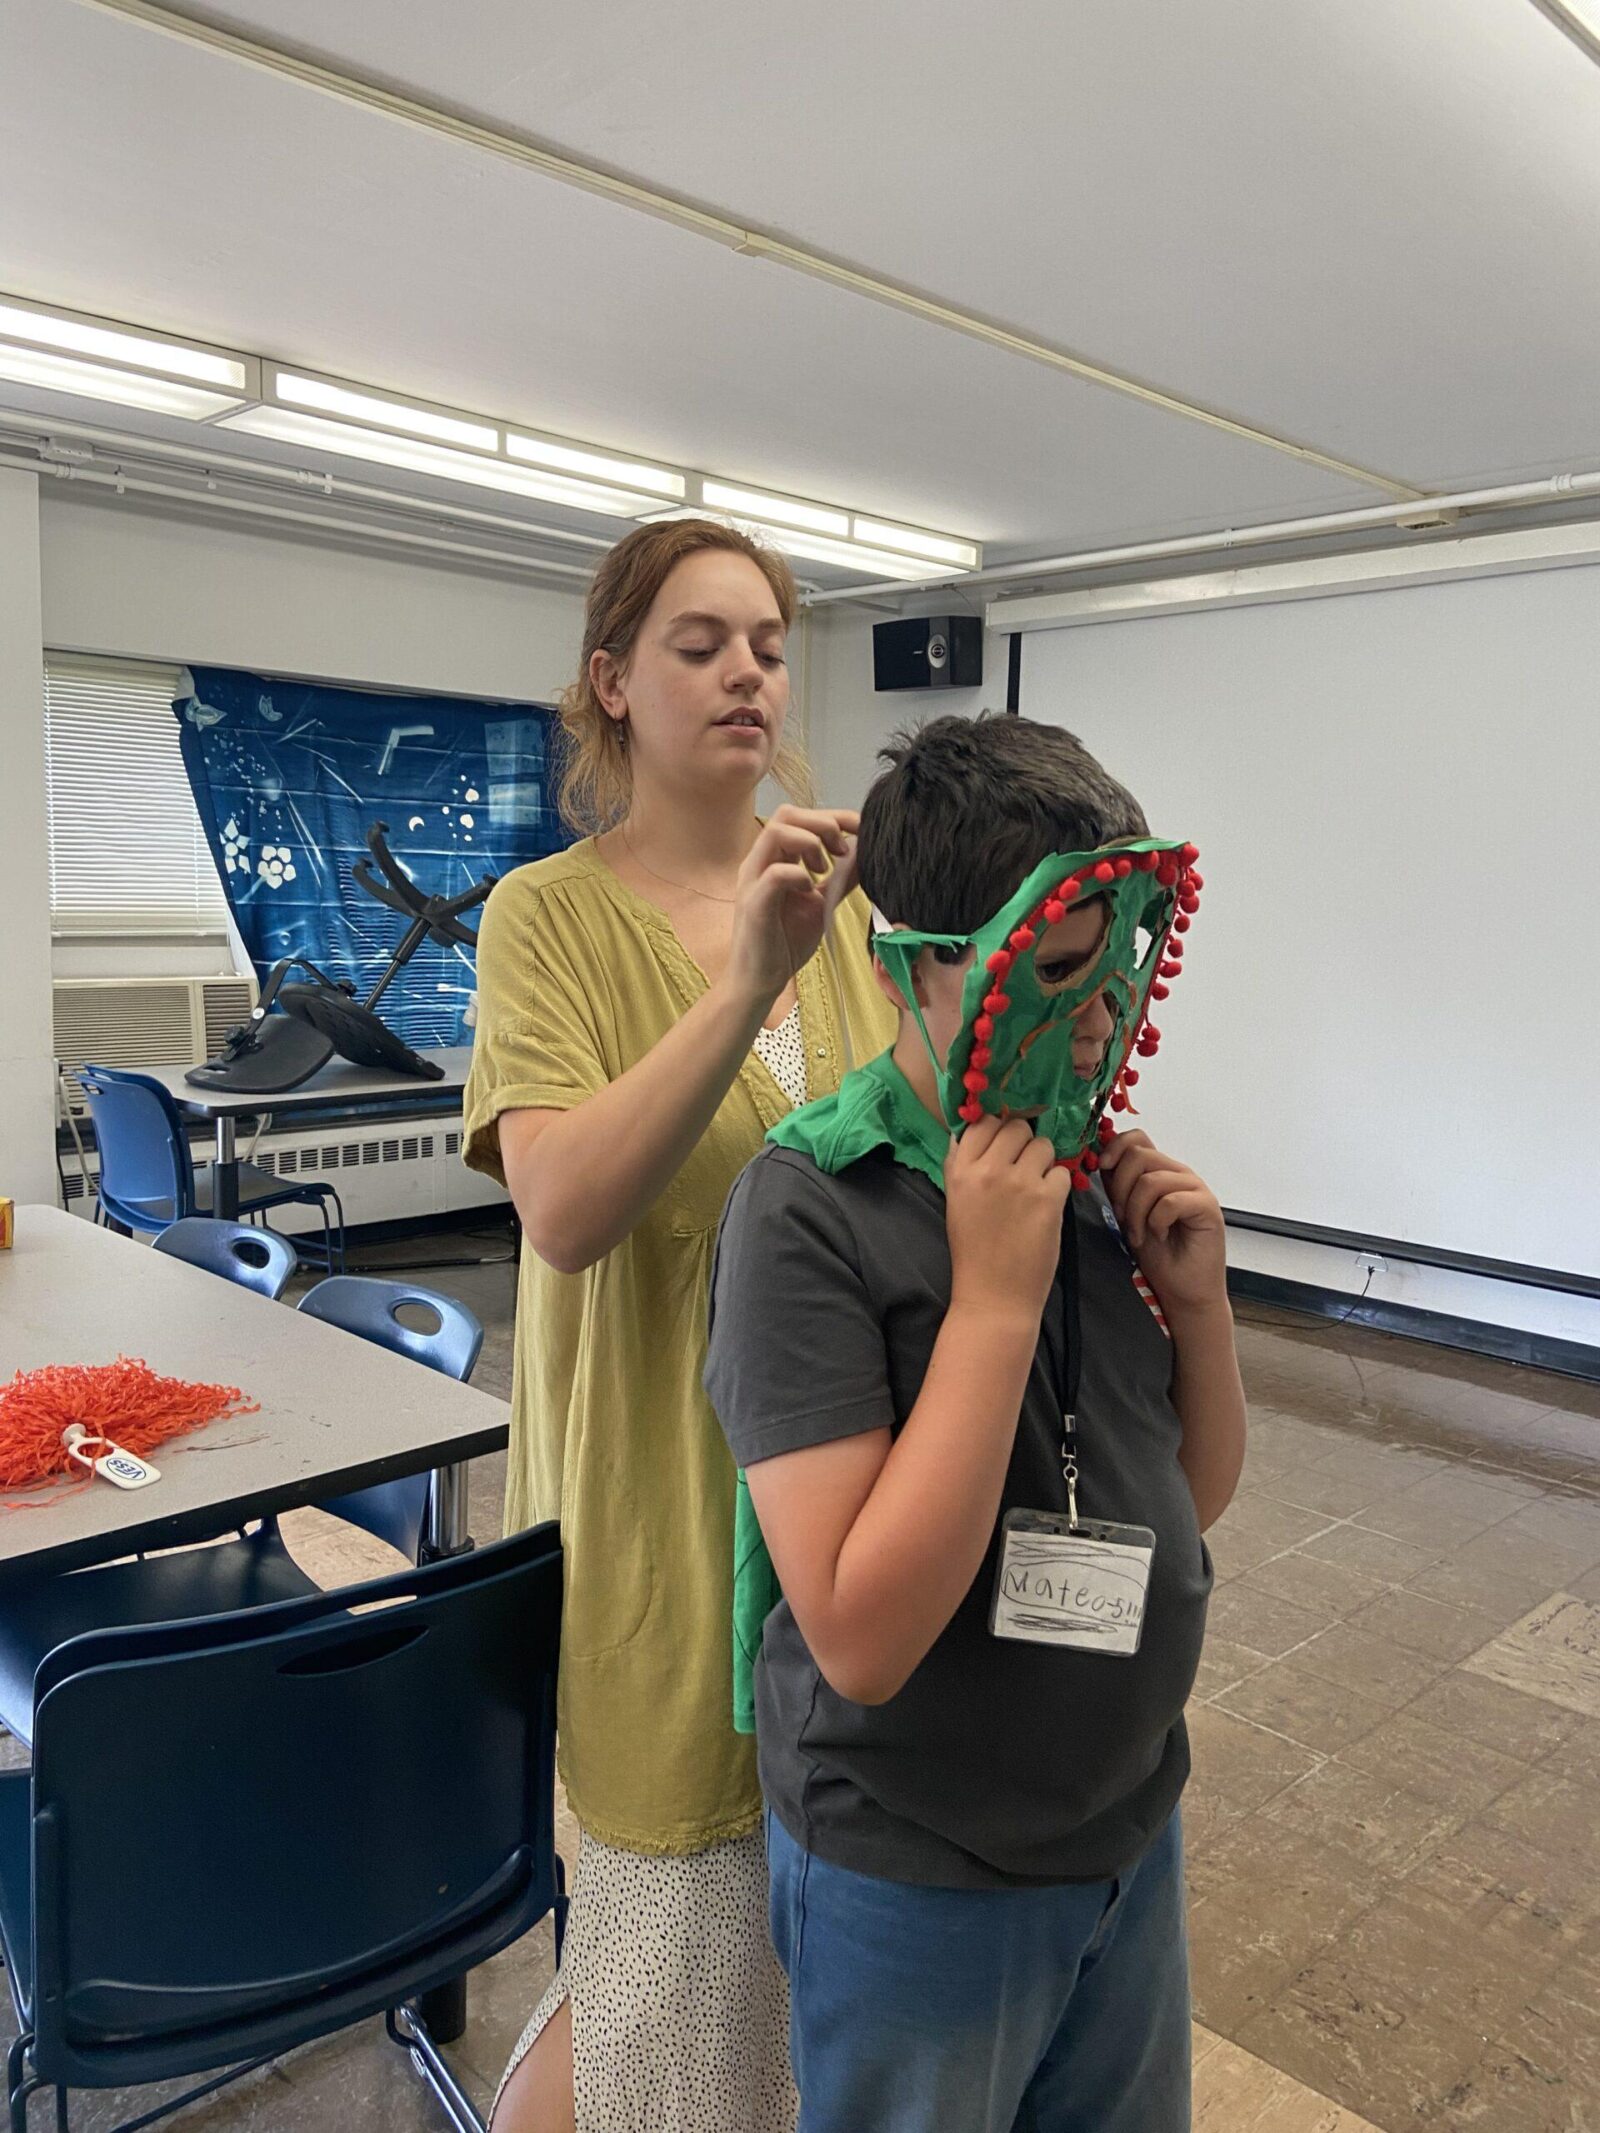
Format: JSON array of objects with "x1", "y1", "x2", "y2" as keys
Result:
[{"x1": 727, "y1": 806, "x2": 862, "y2": 1013}]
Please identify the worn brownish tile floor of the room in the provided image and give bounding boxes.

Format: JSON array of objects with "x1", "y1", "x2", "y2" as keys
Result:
[{"x1": 6, "y1": 1233, "x2": 1600, "y2": 2133}]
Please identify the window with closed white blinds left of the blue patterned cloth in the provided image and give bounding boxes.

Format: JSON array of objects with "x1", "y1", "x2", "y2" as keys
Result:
[{"x1": 45, "y1": 653, "x2": 228, "y2": 939}]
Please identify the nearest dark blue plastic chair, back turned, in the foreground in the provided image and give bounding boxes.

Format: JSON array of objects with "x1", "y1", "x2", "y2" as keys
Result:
[{"x1": 0, "y1": 1525, "x2": 565, "y2": 2133}]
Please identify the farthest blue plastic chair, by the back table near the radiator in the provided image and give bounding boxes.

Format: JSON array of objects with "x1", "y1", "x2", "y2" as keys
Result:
[{"x1": 79, "y1": 1067, "x2": 343, "y2": 1271}]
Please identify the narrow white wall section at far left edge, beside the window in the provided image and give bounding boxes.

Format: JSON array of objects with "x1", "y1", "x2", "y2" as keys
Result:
[{"x1": 0, "y1": 471, "x2": 55, "y2": 1201}]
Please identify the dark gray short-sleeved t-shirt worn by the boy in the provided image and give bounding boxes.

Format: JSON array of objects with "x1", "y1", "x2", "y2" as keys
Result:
[{"x1": 706, "y1": 1145, "x2": 1212, "y2": 1888}]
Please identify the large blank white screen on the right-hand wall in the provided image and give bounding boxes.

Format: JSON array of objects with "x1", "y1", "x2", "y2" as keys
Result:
[{"x1": 1020, "y1": 567, "x2": 1600, "y2": 1273}]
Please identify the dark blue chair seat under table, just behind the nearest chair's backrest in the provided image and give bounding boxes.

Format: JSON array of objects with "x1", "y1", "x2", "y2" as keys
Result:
[{"x1": 0, "y1": 1523, "x2": 320, "y2": 1743}]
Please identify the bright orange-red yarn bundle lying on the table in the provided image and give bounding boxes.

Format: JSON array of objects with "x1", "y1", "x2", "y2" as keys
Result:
[{"x1": 0, "y1": 1354, "x2": 260, "y2": 1489}]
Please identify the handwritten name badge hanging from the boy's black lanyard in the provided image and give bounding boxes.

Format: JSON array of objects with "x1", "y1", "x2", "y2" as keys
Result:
[{"x1": 990, "y1": 1510, "x2": 1156, "y2": 1659}]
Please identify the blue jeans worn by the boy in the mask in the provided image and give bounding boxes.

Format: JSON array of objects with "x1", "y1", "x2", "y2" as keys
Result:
[{"x1": 766, "y1": 1811, "x2": 1190, "y2": 2133}]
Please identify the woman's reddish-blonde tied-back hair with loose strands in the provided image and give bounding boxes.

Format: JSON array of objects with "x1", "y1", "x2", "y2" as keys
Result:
[{"x1": 557, "y1": 518, "x2": 811, "y2": 836}]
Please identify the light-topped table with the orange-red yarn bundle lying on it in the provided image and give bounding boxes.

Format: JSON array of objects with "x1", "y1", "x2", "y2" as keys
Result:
[{"x1": 0, "y1": 1203, "x2": 510, "y2": 1581}]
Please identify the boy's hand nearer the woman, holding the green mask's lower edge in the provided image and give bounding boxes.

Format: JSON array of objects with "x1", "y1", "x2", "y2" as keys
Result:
[{"x1": 945, "y1": 1118, "x2": 1071, "y2": 1327}]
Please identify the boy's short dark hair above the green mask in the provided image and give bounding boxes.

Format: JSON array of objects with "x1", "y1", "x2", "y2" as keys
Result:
[{"x1": 858, "y1": 710, "x2": 1150, "y2": 934}]
